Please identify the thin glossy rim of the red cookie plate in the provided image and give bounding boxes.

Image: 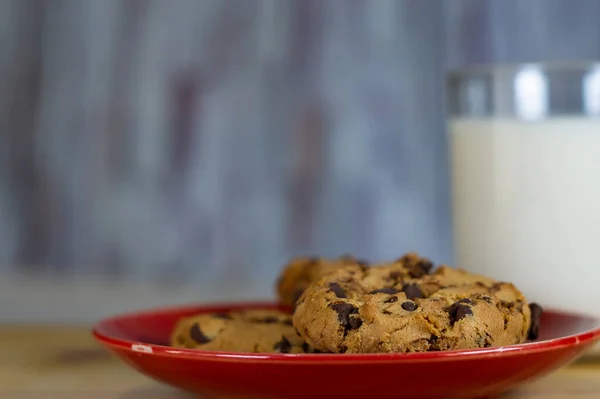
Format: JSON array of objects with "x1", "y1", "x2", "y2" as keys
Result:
[{"x1": 91, "y1": 300, "x2": 600, "y2": 364}]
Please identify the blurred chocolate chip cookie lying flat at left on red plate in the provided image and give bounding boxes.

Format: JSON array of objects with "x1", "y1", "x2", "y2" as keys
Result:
[{"x1": 171, "y1": 310, "x2": 315, "y2": 353}]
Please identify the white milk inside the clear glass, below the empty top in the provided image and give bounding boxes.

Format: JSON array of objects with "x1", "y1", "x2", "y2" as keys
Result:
[{"x1": 449, "y1": 118, "x2": 600, "y2": 315}]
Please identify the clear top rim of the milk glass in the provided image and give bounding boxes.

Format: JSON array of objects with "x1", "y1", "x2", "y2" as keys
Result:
[{"x1": 446, "y1": 59, "x2": 600, "y2": 78}]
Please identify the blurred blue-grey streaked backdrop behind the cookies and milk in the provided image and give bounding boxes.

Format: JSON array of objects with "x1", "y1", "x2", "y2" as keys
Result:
[{"x1": 0, "y1": 0, "x2": 600, "y2": 322}]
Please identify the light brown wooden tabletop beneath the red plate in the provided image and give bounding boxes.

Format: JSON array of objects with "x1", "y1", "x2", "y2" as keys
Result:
[{"x1": 0, "y1": 325, "x2": 600, "y2": 399}]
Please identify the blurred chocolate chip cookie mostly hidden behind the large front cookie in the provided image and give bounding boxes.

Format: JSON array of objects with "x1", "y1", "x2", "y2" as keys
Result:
[{"x1": 276, "y1": 255, "x2": 366, "y2": 306}]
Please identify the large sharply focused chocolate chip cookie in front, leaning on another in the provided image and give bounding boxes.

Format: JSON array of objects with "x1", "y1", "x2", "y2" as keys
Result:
[{"x1": 293, "y1": 254, "x2": 541, "y2": 353}]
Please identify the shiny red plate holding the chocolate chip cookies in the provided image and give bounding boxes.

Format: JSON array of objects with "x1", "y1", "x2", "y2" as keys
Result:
[{"x1": 93, "y1": 303, "x2": 600, "y2": 399}]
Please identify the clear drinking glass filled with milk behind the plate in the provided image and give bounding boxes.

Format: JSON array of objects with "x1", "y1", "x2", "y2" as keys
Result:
[{"x1": 447, "y1": 63, "x2": 600, "y2": 315}]
